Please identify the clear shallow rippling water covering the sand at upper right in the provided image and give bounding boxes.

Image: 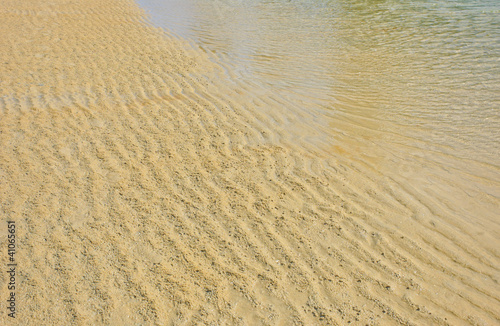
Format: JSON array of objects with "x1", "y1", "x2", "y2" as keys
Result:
[{"x1": 138, "y1": 0, "x2": 500, "y2": 222}]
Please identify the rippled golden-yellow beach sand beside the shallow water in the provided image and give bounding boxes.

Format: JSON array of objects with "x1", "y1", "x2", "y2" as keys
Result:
[{"x1": 0, "y1": 0, "x2": 500, "y2": 325}]
